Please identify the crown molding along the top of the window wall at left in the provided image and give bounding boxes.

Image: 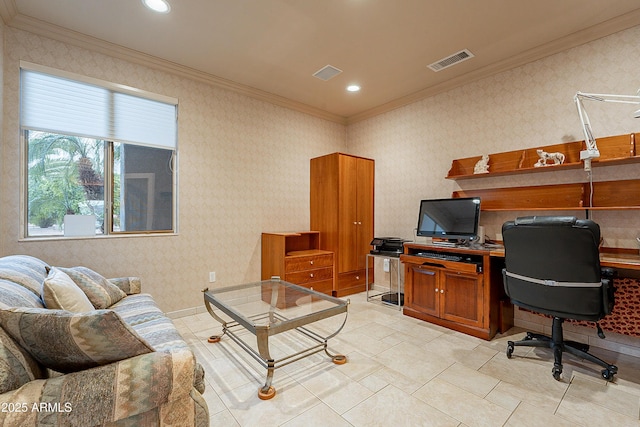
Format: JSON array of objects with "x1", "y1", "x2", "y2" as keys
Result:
[{"x1": 0, "y1": 11, "x2": 347, "y2": 125}]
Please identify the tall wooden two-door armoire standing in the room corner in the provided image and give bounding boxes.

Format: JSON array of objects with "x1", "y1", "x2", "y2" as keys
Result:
[{"x1": 311, "y1": 153, "x2": 375, "y2": 297}]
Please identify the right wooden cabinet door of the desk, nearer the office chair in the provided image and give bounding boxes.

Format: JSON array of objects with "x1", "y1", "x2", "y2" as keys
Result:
[{"x1": 440, "y1": 271, "x2": 484, "y2": 327}]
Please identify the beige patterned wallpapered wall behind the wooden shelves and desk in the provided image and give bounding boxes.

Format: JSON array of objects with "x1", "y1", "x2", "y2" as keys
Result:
[{"x1": 347, "y1": 23, "x2": 640, "y2": 248}]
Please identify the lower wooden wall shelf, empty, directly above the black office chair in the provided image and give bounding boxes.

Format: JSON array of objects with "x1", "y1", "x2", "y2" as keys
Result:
[{"x1": 453, "y1": 179, "x2": 640, "y2": 211}]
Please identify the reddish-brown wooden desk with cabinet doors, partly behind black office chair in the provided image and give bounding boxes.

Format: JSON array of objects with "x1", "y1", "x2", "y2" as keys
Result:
[{"x1": 400, "y1": 243, "x2": 640, "y2": 340}]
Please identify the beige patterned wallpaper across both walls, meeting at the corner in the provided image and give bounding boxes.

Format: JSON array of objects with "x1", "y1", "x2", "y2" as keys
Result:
[{"x1": 0, "y1": 27, "x2": 640, "y2": 311}]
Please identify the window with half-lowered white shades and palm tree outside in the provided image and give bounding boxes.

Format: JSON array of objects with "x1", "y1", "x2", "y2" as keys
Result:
[{"x1": 20, "y1": 63, "x2": 177, "y2": 237}]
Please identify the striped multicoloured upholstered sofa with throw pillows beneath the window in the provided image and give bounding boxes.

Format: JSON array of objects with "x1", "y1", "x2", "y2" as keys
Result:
[{"x1": 0, "y1": 255, "x2": 209, "y2": 427}]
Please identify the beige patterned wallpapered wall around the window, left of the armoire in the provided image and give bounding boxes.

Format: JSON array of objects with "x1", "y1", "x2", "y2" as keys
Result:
[{"x1": 0, "y1": 27, "x2": 346, "y2": 311}]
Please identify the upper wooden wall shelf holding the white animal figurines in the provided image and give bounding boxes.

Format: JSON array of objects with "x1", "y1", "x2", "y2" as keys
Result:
[{"x1": 446, "y1": 133, "x2": 640, "y2": 181}]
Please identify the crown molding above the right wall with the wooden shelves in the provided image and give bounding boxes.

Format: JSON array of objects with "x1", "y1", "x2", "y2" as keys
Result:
[{"x1": 347, "y1": 9, "x2": 640, "y2": 125}]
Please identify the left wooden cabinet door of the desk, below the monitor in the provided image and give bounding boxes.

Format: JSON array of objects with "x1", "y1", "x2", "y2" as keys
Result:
[{"x1": 405, "y1": 265, "x2": 440, "y2": 316}]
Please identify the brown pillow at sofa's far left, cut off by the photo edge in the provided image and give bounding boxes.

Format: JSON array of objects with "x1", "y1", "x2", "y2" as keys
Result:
[{"x1": 0, "y1": 329, "x2": 45, "y2": 394}]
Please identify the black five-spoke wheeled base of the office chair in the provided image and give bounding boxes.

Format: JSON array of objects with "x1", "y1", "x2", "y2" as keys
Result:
[{"x1": 507, "y1": 317, "x2": 618, "y2": 381}]
